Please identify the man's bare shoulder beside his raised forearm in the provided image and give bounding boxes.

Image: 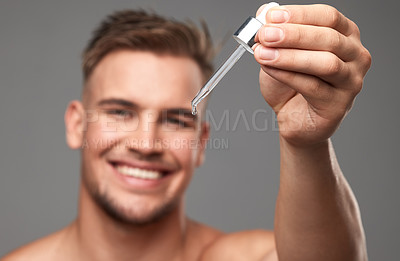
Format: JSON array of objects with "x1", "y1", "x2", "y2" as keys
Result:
[{"x1": 201, "y1": 229, "x2": 278, "y2": 261}]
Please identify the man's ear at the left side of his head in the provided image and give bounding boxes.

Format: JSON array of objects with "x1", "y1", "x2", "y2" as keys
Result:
[{"x1": 64, "y1": 100, "x2": 85, "y2": 149}]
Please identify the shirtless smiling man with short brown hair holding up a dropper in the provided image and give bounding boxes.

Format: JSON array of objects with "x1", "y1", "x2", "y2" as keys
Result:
[{"x1": 4, "y1": 2, "x2": 371, "y2": 261}]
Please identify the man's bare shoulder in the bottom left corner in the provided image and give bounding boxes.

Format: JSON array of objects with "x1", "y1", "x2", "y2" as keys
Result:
[{"x1": 1, "y1": 224, "x2": 72, "y2": 261}]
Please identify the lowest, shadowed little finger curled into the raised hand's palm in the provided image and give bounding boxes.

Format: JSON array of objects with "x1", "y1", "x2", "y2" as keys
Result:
[{"x1": 261, "y1": 66, "x2": 337, "y2": 110}]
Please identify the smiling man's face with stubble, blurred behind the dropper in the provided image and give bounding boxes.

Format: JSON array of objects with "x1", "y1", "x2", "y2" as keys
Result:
[{"x1": 74, "y1": 50, "x2": 208, "y2": 224}]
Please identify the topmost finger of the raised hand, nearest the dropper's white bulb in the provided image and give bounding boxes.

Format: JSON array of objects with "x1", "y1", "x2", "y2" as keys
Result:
[{"x1": 266, "y1": 4, "x2": 359, "y2": 36}]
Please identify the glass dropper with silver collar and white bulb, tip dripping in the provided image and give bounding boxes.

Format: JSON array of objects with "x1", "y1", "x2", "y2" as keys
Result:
[{"x1": 192, "y1": 2, "x2": 279, "y2": 115}]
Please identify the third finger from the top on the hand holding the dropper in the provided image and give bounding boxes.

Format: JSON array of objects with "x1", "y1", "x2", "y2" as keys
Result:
[{"x1": 254, "y1": 45, "x2": 351, "y2": 87}]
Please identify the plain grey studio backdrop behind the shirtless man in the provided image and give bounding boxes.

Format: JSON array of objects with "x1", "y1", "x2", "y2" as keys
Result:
[{"x1": 0, "y1": 0, "x2": 400, "y2": 260}]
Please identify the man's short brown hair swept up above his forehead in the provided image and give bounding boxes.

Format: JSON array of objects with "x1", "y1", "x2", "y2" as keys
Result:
[{"x1": 82, "y1": 10, "x2": 215, "y2": 82}]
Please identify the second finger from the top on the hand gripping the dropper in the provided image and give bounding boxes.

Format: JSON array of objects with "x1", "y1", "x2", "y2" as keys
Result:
[{"x1": 256, "y1": 24, "x2": 359, "y2": 61}]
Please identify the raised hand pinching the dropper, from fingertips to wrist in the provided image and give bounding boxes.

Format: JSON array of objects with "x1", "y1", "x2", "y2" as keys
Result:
[{"x1": 254, "y1": 5, "x2": 371, "y2": 146}]
